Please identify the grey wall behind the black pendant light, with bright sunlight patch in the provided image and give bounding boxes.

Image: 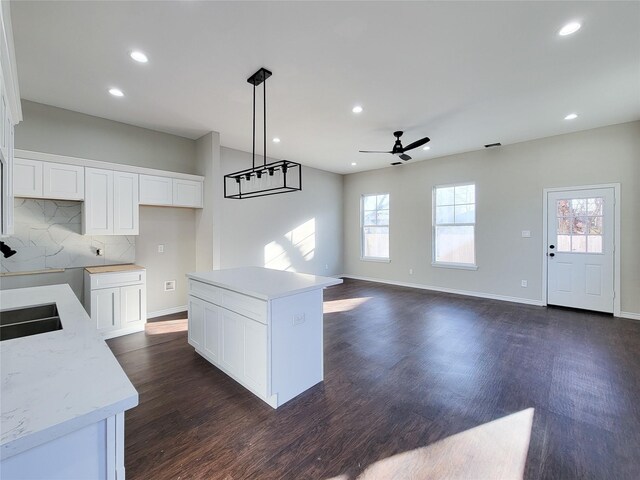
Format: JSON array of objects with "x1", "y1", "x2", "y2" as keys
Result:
[{"x1": 221, "y1": 147, "x2": 343, "y2": 275}]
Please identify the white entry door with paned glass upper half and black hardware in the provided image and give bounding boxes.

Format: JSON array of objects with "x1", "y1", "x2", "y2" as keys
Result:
[{"x1": 547, "y1": 188, "x2": 615, "y2": 313}]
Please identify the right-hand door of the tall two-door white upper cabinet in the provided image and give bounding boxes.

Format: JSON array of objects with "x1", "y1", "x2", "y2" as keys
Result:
[{"x1": 113, "y1": 172, "x2": 139, "y2": 235}]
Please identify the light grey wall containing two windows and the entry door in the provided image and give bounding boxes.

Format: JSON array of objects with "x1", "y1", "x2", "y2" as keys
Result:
[{"x1": 344, "y1": 122, "x2": 640, "y2": 314}]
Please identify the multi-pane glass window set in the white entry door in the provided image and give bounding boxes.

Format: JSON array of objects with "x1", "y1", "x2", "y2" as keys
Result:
[{"x1": 556, "y1": 197, "x2": 604, "y2": 253}]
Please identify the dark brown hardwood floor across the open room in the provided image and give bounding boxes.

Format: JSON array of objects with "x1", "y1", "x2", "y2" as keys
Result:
[{"x1": 108, "y1": 280, "x2": 640, "y2": 480}]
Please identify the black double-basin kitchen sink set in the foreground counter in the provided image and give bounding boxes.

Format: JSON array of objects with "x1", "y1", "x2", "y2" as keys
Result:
[{"x1": 0, "y1": 303, "x2": 62, "y2": 341}]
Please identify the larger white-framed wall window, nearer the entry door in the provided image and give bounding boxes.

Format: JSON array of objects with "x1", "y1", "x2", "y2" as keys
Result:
[{"x1": 433, "y1": 183, "x2": 476, "y2": 268}]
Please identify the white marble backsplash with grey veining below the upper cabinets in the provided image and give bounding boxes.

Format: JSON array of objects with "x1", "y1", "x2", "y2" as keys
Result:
[{"x1": 0, "y1": 198, "x2": 136, "y2": 272}]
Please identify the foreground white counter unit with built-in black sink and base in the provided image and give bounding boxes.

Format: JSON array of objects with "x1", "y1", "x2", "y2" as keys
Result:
[{"x1": 0, "y1": 285, "x2": 138, "y2": 480}]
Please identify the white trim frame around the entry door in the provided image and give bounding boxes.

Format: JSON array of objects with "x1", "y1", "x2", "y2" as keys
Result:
[{"x1": 542, "y1": 183, "x2": 620, "y2": 317}]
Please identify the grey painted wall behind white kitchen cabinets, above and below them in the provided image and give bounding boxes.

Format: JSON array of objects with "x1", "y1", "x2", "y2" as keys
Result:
[{"x1": 2, "y1": 100, "x2": 196, "y2": 313}]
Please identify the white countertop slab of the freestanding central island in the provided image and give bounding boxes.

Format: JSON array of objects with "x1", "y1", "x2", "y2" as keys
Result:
[{"x1": 187, "y1": 267, "x2": 342, "y2": 300}]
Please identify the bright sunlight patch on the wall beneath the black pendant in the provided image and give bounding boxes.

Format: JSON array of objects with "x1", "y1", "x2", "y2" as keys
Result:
[{"x1": 264, "y1": 218, "x2": 316, "y2": 272}]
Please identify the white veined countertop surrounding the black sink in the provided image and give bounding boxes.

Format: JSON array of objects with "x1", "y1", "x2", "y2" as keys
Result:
[{"x1": 0, "y1": 285, "x2": 138, "y2": 459}]
